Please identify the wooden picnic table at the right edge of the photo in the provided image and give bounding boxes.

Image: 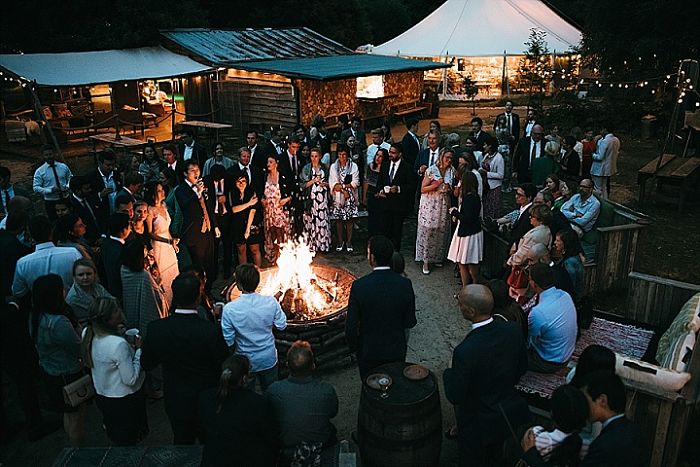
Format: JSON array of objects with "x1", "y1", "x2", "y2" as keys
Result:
[{"x1": 637, "y1": 154, "x2": 700, "y2": 211}]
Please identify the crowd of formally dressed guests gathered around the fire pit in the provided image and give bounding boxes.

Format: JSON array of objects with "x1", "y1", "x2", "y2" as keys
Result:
[{"x1": 0, "y1": 102, "x2": 624, "y2": 465}]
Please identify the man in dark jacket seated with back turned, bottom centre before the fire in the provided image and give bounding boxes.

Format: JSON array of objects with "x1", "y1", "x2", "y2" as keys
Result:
[{"x1": 267, "y1": 341, "x2": 338, "y2": 466}]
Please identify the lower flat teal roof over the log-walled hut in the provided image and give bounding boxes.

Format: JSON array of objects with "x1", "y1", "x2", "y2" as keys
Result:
[{"x1": 234, "y1": 54, "x2": 450, "y2": 81}]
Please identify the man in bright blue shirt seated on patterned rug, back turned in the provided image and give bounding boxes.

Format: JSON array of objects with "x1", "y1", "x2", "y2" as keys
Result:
[{"x1": 527, "y1": 263, "x2": 578, "y2": 373}]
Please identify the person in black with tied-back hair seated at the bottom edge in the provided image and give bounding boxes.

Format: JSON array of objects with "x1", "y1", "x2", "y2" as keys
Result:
[{"x1": 198, "y1": 354, "x2": 279, "y2": 467}]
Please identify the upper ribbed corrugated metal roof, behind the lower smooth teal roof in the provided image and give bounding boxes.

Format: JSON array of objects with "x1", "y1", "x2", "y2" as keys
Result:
[{"x1": 160, "y1": 28, "x2": 352, "y2": 66}]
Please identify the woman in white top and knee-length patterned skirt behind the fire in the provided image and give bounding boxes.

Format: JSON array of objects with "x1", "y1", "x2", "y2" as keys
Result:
[{"x1": 328, "y1": 146, "x2": 360, "y2": 253}]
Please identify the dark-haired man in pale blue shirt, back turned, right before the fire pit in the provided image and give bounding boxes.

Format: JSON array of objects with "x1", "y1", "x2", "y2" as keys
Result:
[{"x1": 221, "y1": 264, "x2": 287, "y2": 391}]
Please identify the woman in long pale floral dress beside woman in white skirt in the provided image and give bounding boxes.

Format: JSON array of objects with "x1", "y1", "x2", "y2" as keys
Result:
[{"x1": 416, "y1": 148, "x2": 455, "y2": 274}]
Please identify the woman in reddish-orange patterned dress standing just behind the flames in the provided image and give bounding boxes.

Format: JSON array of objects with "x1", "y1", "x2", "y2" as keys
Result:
[{"x1": 261, "y1": 155, "x2": 292, "y2": 264}]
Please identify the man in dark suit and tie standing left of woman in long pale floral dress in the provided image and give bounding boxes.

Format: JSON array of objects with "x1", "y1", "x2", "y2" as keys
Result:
[{"x1": 377, "y1": 143, "x2": 415, "y2": 251}]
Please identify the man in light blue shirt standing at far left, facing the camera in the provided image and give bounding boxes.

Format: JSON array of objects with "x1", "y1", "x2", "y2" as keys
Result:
[{"x1": 32, "y1": 144, "x2": 73, "y2": 222}]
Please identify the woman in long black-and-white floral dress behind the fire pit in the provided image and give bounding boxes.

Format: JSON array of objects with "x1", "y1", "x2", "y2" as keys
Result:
[{"x1": 299, "y1": 147, "x2": 331, "y2": 253}]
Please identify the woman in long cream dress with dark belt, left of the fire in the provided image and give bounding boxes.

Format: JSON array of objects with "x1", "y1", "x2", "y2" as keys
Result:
[{"x1": 144, "y1": 182, "x2": 180, "y2": 311}]
